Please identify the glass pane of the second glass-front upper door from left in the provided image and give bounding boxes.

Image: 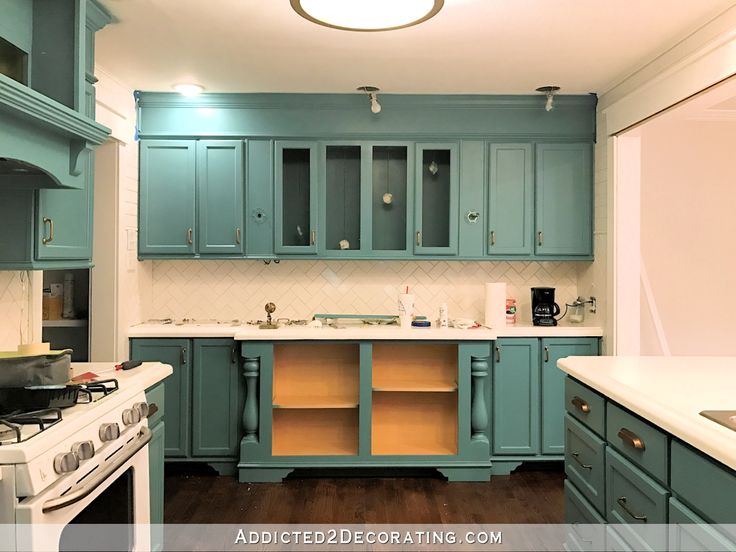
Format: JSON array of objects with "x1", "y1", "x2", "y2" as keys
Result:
[{"x1": 326, "y1": 146, "x2": 360, "y2": 250}]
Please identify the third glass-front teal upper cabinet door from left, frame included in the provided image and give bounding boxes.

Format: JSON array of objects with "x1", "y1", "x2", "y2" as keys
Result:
[{"x1": 370, "y1": 142, "x2": 414, "y2": 257}]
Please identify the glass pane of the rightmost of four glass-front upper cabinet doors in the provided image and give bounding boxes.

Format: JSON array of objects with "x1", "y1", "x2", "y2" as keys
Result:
[{"x1": 422, "y1": 150, "x2": 450, "y2": 247}]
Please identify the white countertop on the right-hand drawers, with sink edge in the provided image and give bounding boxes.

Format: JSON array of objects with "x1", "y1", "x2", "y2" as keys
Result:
[{"x1": 557, "y1": 357, "x2": 736, "y2": 469}]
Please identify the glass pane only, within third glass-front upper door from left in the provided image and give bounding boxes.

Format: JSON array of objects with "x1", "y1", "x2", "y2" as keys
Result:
[{"x1": 371, "y1": 146, "x2": 406, "y2": 251}]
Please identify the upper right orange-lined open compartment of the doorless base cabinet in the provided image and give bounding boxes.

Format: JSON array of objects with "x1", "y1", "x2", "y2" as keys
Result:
[{"x1": 372, "y1": 343, "x2": 458, "y2": 392}]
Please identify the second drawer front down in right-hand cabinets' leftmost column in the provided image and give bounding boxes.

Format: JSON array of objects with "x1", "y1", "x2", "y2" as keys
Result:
[{"x1": 565, "y1": 414, "x2": 606, "y2": 512}]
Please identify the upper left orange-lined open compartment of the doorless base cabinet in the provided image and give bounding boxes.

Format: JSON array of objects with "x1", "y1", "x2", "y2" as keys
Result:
[{"x1": 272, "y1": 343, "x2": 360, "y2": 409}]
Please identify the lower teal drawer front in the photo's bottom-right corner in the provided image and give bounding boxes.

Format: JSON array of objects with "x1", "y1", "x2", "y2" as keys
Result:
[{"x1": 669, "y1": 498, "x2": 736, "y2": 552}]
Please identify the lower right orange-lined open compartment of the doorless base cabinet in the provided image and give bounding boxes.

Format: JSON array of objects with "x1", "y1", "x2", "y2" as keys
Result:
[{"x1": 371, "y1": 392, "x2": 457, "y2": 456}]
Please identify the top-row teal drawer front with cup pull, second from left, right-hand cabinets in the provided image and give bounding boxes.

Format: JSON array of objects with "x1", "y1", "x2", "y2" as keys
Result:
[{"x1": 606, "y1": 402, "x2": 669, "y2": 483}]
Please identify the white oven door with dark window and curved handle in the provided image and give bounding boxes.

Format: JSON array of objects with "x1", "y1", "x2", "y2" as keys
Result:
[{"x1": 15, "y1": 426, "x2": 152, "y2": 551}]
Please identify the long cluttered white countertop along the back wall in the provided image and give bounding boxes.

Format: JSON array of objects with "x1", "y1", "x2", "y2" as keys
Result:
[{"x1": 128, "y1": 323, "x2": 603, "y2": 341}]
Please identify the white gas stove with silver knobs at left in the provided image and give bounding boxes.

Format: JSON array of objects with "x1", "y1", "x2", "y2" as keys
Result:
[{"x1": 0, "y1": 363, "x2": 171, "y2": 550}]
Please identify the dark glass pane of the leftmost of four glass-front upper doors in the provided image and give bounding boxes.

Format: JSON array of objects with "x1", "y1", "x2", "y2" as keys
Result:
[{"x1": 282, "y1": 148, "x2": 311, "y2": 246}]
